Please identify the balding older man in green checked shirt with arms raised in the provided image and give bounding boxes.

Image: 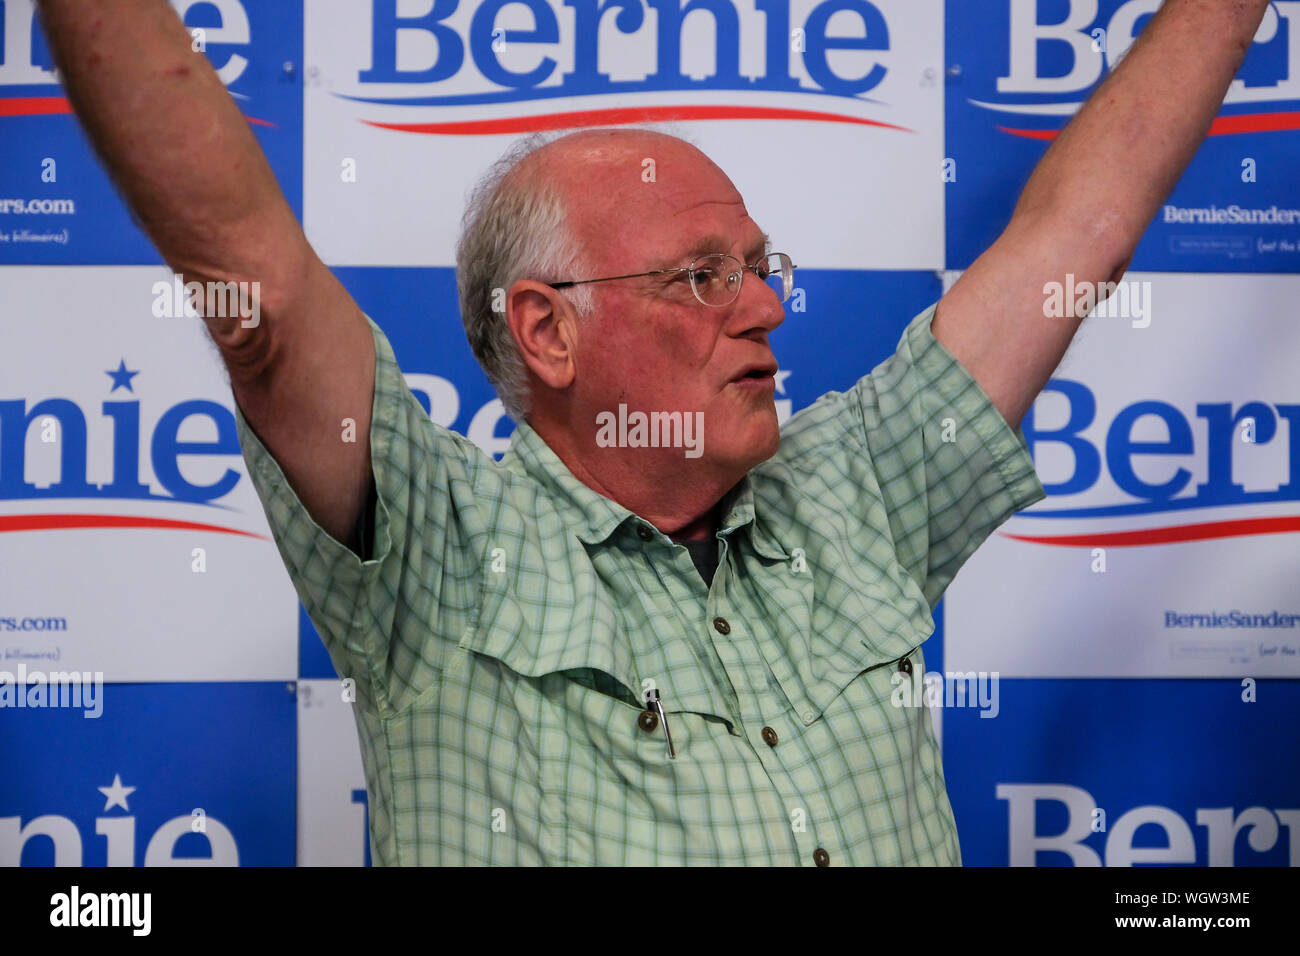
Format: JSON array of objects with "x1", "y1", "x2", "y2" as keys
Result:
[{"x1": 43, "y1": 0, "x2": 1265, "y2": 866}]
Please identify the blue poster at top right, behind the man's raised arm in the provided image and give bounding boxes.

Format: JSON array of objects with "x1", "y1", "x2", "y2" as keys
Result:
[{"x1": 945, "y1": 0, "x2": 1300, "y2": 272}]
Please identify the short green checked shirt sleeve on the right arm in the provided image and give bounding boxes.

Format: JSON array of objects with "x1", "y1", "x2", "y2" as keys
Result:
[{"x1": 848, "y1": 303, "x2": 1047, "y2": 607}]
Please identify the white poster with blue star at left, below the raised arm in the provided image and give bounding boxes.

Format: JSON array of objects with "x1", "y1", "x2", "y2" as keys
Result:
[{"x1": 0, "y1": 267, "x2": 298, "y2": 682}]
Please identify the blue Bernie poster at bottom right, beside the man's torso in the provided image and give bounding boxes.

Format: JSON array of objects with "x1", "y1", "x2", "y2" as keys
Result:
[{"x1": 944, "y1": 679, "x2": 1300, "y2": 866}]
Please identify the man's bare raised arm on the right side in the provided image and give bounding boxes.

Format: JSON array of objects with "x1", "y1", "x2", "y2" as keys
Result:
[{"x1": 931, "y1": 0, "x2": 1268, "y2": 427}]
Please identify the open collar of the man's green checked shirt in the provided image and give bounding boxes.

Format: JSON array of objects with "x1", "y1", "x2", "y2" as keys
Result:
[{"x1": 502, "y1": 421, "x2": 790, "y2": 561}]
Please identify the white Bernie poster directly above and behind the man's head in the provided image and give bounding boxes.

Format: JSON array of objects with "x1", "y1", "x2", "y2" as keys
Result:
[{"x1": 303, "y1": 0, "x2": 944, "y2": 269}]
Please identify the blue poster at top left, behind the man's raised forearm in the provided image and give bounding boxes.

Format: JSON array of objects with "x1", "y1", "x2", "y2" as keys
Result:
[{"x1": 0, "y1": 0, "x2": 303, "y2": 265}]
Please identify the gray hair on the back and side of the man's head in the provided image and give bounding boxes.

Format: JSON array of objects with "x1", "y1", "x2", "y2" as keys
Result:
[{"x1": 456, "y1": 133, "x2": 594, "y2": 421}]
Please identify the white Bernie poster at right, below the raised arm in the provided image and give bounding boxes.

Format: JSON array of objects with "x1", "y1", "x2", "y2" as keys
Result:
[{"x1": 945, "y1": 273, "x2": 1300, "y2": 678}]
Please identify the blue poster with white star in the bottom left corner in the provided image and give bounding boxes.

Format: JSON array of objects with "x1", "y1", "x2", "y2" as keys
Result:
[{"x1": 0, "y1": 681, "x2": 298, "y2": 866}]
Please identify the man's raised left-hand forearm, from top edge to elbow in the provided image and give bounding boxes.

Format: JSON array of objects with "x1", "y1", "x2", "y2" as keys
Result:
[{"x1": 40, "y1": 0, "x2": 300, "y2": 287}]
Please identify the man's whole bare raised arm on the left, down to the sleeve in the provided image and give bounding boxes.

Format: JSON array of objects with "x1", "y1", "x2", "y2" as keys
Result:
[{"x1": 40, "y1": 0, "x2": 374, "y2": 544}]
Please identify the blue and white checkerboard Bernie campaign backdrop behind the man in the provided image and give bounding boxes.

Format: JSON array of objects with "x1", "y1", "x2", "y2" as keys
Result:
[{"x1": 0, "y1": 0, "x2": 1300, "y2": 866}]
